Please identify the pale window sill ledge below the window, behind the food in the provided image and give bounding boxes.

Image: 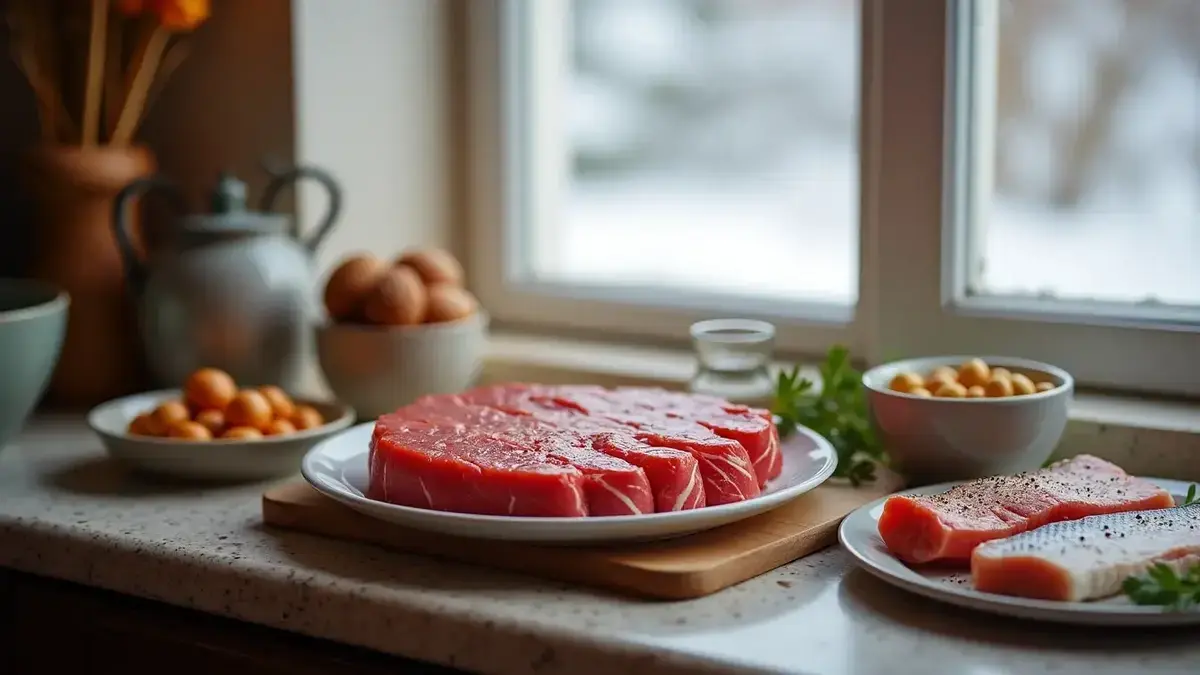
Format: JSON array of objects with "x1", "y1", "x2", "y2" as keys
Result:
[{"x1": 484, "y1": 331, "x2": 1200, "y2": 479}]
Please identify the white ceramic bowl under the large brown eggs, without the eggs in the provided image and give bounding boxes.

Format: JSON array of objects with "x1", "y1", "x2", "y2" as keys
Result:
[{"x1": 317, "y1": 311, "x2": 488, "y2": 419}]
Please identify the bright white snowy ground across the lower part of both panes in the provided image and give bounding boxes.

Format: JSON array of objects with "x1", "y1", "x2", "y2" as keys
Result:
[{"x1": 541, "y1": 150, "x2": 1200, "y2": 304}]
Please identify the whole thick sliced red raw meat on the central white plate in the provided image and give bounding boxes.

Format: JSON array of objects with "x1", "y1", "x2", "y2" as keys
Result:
[{"x1": 371, "y1": 384, "x2": 780, "y2": 515}]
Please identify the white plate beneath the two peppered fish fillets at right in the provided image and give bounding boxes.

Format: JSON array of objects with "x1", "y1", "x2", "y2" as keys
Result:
[{"x1": 838, "y1": 478, "x2": 1200, "y2": 626}]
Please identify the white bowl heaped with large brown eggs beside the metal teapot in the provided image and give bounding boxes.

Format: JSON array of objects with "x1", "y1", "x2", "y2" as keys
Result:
[{"x1": 317, "y1": 243, "x2": 488, "y2": 419}]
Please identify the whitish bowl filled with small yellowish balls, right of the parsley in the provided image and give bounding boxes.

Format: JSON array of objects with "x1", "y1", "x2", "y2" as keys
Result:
[{"x1": 863, "y1": 357, "x2": 1075, "y2": 485}]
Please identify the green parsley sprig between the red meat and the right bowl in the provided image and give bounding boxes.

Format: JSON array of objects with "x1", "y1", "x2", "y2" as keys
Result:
[{"x1": 770, "y1": 346, "x2": 886, "y2": 486}]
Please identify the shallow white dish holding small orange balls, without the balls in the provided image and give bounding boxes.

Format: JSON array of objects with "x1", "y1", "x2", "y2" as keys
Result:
[{"x1": 88, "y1": 389, "x2": 354, "y2": 480}]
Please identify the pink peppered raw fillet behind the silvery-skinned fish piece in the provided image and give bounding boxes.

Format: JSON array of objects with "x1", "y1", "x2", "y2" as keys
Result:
[{"x1": 880, "y1": 455, "x2": 1175, "y2": 565}]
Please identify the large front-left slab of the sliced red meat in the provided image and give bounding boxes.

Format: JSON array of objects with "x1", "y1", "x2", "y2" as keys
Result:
[{"x1": 367, "y1": 422, "x2": 588, "y2": 516}]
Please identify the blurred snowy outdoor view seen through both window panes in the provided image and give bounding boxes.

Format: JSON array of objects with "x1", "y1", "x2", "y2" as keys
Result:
[{"x1": 536, "y1": 0, "x2": 1200, "y2": 304}]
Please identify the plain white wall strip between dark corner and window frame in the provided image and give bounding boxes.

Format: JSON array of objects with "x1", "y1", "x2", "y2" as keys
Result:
[{"x1": 292, "y1": 0, "x2": 454, "y2": 274}]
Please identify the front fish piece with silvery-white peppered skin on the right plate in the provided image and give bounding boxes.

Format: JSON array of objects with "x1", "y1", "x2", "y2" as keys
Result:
[{"x1": 971, "y1": 502, "x2": 1200, "y2": 602}]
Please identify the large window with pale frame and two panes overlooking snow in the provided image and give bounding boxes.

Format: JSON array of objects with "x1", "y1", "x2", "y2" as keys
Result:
[{"x1": 469, "y1": 0, "x2": 1200, "y2": 394}]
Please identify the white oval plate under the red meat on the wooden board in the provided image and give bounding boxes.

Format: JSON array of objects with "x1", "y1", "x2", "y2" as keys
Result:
[{"x1": 300, "y1": 423, "x2": 838, "y2": 544}]
